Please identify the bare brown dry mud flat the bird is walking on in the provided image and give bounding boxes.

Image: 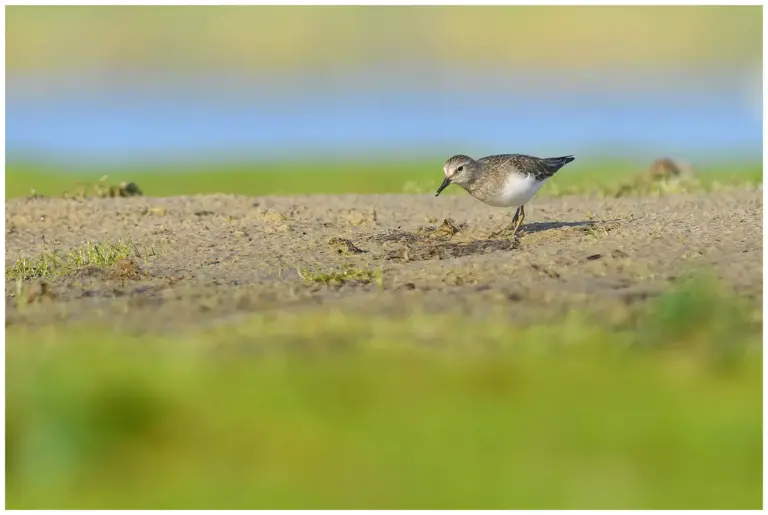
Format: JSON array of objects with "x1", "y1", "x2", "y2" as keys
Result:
[{"x1": 6, "y1": 188, "x2": 763, "y2": 331}]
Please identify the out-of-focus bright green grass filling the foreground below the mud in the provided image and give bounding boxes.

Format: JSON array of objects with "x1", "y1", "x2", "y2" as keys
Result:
[{"x1": 6, "y1": 281, "x2": 762, "y2": 509}]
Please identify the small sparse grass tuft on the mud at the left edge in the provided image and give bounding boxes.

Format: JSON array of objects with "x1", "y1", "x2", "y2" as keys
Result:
[{"x1": 5, "y1": 240, "x2": 133, "y2": 280}]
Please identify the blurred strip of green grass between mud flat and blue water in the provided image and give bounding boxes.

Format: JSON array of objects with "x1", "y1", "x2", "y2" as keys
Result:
[{"x1": 5, "y1": 160, "x2": 762, "y2": 198}]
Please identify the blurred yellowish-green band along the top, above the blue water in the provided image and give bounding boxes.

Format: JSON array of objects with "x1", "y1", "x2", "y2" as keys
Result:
[{"x1": 7, "y1": 6, "x2": 762, "y2": 74}]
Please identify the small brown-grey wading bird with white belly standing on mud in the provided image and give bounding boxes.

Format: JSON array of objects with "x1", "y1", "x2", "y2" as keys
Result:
[{"x1": 435, "y1": 154, "x2": 576, "y2": 237}]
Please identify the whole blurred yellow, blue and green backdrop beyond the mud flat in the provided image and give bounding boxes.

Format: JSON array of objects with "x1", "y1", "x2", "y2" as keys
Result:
[{"x1": 6, "y1": 6, "x2": 762, "y2": 196}]
